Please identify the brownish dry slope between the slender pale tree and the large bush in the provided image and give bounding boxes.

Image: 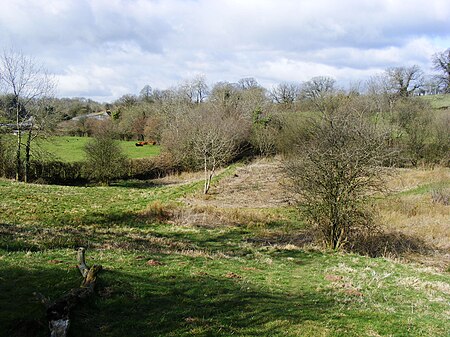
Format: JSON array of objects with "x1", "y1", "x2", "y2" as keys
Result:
[{"x1": 184, "y1": 159, "x2": 291, "y2": 208}]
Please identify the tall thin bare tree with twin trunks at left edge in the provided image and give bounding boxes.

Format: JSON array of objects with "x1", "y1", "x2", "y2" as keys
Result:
[{"x1": 0, "y1": 50, "x2": 55, "y2": 180}]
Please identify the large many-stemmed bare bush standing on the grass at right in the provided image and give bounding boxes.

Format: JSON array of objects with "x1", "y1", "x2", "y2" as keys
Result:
[{"x1": 287, "y1": 106, "x2": 385, "y2": 249}]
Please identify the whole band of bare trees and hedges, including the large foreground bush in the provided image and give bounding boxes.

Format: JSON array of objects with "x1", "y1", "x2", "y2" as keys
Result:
[{"x1": 0, "y1": 49, "x2": 450, "y2": 249}]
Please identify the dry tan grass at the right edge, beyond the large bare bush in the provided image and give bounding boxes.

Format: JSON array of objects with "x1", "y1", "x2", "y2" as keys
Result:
[{"x1": 377, "y1": 167, "x2": 450, "y2": 270}]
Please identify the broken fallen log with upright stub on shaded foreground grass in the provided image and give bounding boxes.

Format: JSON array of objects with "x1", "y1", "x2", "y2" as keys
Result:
[{"x1": 38, "y1": 247, "x2": 102, "y2": 337}]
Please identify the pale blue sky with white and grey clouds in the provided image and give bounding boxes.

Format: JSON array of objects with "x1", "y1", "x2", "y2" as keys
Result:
[{"x1": 0, "y1": 0, "x2": 450, "y2": 102}]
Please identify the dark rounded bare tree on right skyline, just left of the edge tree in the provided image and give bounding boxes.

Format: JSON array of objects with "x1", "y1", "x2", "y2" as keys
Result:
[{"x1": 385, "y1": 65, "x2": 425, "y2": 97}]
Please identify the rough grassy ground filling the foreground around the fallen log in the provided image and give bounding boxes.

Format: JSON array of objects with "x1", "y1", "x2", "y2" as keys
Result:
[{"x1": 0, "y1": 163, "x2": 450, "y2": 337}]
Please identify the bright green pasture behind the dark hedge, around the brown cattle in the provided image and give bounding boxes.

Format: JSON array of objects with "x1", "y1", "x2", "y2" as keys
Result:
[{"x1": 40, "y1": 137, "x2": 160, "y2": 162}]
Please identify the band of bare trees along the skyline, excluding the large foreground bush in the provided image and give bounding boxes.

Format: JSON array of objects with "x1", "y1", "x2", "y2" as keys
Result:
[{"x1": 0, "y1": 50, "x2": 450, "y2": 186}]
